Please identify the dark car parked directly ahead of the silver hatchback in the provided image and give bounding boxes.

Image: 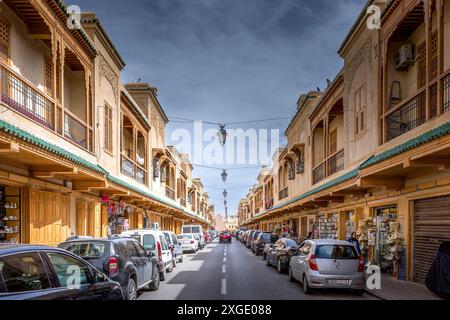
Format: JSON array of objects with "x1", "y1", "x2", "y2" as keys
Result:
[{"x1": 266, "y1": 238, "x2": 298, "y2": 273}]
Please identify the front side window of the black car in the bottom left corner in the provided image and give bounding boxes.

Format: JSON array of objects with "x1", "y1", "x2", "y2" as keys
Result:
[{"x1": 47, "y1": 253, "x2": 91, "y2": 287}]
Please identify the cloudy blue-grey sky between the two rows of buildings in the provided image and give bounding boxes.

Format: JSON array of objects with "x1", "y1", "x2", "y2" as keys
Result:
[{"x1": 66, "y1": 0, "x2": 365, "y2": 215}]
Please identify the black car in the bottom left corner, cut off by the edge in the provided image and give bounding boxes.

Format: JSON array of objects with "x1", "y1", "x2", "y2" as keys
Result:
[{"x1": 0, "y1": 244, "x2": 124, "y2": 300}]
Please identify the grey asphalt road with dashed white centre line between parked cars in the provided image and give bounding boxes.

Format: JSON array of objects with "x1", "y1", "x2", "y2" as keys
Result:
[{"x1": 138, "y1": 239, "x2": 376, "y2": 300}]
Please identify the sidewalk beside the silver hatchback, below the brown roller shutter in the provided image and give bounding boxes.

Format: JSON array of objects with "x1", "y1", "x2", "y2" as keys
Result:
[{"x1": 366, "y1": 274, "x2": 443, "y2": 300}]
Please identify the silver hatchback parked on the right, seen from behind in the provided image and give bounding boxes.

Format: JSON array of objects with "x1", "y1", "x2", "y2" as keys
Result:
[{"x1": 289, "y1": 240, "x2": 364, "y2": 294}]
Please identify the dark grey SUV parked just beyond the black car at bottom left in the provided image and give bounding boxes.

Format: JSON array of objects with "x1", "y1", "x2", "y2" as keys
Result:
[{"x1": 59, "y1": 236, "x2": 160, "y2": 300}]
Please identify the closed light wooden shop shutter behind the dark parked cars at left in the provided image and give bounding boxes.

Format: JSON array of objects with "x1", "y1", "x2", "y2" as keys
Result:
[{"x1": 30, "y1": 190, "x2": 70, "y2": 246}]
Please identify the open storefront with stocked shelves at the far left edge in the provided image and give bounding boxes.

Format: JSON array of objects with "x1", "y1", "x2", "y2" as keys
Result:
[{"x1": 0, "y1": 186, "x2": 22, "y2": 243}]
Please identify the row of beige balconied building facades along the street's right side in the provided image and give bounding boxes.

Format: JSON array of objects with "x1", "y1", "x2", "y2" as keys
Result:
[{"x1": 239, "y1": 0, "x2": 450, "y2": 283}]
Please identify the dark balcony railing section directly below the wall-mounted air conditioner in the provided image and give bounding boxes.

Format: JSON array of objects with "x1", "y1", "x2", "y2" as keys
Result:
[{"x1": 386, "y1": 91, "x2": 426, "y2": 141}]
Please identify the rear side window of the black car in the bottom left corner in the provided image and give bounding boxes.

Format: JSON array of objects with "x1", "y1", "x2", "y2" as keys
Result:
[{"x1": 0, "y1": 253, "x2": 50, "y2": 293}]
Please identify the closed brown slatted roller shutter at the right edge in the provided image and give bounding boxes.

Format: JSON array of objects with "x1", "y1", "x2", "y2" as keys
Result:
[{"x1": 413, "y1": 196, "x2": 450, "y2": 283}]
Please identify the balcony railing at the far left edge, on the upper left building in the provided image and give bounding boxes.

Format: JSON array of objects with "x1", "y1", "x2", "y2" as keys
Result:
[{"x1": 1, "y1": 66, "x2": 54, "y2": 129}]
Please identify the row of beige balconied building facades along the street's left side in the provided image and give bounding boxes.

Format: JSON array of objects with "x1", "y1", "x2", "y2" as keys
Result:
[{"x1": 0, "y1": 0, "x2": 213, "y2": 245}]
